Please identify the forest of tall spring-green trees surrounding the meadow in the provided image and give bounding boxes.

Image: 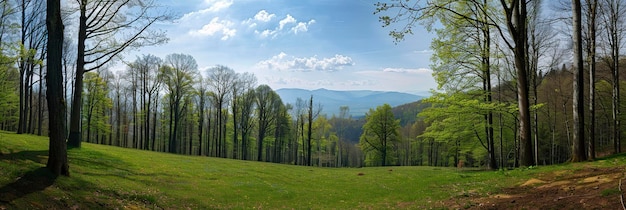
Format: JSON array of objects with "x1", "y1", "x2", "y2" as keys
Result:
[{"x1": 0, "y1": 0, "x2": 626, "y2": 178}]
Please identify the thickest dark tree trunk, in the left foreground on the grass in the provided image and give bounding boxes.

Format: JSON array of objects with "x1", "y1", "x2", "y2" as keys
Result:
[{"x1": 46, "y1": 0, "x2": 70, "y2": 176}]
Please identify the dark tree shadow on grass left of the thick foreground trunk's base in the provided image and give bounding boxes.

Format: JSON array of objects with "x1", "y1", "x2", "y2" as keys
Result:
[{"x1": 0, "y1": 167, "x2": 57, "y2": 203}]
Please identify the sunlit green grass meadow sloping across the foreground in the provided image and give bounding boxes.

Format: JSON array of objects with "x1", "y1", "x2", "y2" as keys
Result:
[{"x1": 0, "y1": 132, "x2": 624, "y2": 209}]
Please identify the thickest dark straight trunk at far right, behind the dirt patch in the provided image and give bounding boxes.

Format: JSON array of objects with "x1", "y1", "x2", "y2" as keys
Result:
[{"x1": 572, "y1": 0, "x2": 587, "y2": 162}]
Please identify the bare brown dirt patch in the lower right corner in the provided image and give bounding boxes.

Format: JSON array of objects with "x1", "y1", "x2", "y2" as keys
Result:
[{"x1": 444, "y1": 166, "x2": 626, "y2": 209}]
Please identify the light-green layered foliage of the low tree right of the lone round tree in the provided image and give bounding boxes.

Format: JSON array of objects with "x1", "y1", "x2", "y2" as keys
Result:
[{"x1": 418, "y1": 91, "x2": 516, "y2": 166}]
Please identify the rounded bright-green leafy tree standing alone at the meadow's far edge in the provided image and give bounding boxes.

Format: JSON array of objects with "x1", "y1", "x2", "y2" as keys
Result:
[{"x1": 361, "y1": 104, "x2": 400, "y2": 166}]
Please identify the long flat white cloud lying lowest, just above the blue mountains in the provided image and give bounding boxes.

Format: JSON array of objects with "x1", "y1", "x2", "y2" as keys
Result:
[{"x1": 257, "y1": 52, "x2": 354, "y2": 72}]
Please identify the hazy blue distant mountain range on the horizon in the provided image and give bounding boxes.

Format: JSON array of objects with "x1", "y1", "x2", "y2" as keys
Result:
[{"x1": 276, "y1": 88, "x2": 423, "y2": 117}]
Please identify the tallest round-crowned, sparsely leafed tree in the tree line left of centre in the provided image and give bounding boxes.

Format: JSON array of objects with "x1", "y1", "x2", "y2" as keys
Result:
[{"x1": 161, "y1": 54, "x2": 198, "y2": 153}]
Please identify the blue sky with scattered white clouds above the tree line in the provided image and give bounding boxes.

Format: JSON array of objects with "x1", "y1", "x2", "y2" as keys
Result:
[{"x1": 122, "y1": 0, "x2": 436, "y2": 95}]
